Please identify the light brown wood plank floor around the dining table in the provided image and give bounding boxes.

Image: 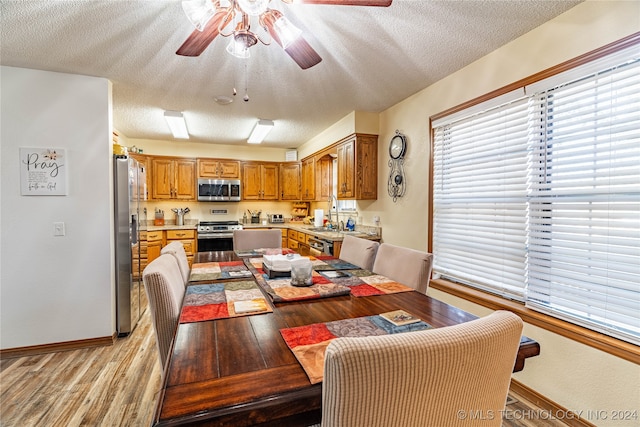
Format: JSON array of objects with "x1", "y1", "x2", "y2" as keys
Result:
[{"x1": 0, "y1": 310, "x2": 565, "y2": 427}]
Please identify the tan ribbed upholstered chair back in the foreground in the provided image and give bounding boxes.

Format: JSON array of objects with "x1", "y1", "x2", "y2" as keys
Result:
[{"x1": 322, "y1": 311, "x2": 522, "y2": 427}]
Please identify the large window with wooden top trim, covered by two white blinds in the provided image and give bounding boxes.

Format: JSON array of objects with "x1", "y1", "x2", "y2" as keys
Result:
[{"x1": 432, "y1": 41, "x2": 640, "y2": 344}]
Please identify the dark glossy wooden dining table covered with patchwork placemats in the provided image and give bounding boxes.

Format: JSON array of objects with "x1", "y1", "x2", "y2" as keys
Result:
[{"x1": 153, "y1": 251, "x2": 540, "y2": 427}]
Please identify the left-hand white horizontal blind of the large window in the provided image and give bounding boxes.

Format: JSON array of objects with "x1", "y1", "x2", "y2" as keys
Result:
[{"x1": 433, "y1": 98, "x2": 528, "y2": 300}]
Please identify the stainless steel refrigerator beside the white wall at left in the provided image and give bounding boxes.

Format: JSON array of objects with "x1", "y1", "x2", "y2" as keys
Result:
[{"x1": 113, "y1": 156, "x2": 147, "y2": 336}]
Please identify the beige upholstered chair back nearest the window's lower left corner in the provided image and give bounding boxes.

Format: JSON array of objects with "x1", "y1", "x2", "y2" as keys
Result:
[{"x1": 373, "y1": 243, "x2": 433, "y2": 293}]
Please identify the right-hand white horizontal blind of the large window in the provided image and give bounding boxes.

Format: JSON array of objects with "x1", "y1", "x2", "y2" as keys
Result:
[{"x1": 527, "y1": 56, "x2": 640, "y2": 344}]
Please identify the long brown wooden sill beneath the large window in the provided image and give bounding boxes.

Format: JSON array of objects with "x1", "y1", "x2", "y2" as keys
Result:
[{"x1": 429, "y1": 279, "x2": 640, "y2": 364}]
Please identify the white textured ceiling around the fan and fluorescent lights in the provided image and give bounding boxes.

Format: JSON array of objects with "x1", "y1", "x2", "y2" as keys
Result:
[{"x1": 0, "y1": 0, "x2": 582, "y2": 148}]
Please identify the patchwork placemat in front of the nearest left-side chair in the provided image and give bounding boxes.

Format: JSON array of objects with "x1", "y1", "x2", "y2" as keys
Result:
[{"x1": 180, "y1": 280, "x2": 273, "y2": 323}]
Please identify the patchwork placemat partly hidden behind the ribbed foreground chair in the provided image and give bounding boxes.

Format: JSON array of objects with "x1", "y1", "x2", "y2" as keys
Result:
[{"x1": 280, "y1": 315, "x2": 432, "y2": 384}]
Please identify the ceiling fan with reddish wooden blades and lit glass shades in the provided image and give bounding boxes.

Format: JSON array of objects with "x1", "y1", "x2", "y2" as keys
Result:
[{"x1": 176, "y1": 0, "x2": 392, "y2": 69}]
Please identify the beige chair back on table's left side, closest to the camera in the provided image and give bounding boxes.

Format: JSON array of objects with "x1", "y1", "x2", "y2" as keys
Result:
[{"x1": 142, "y1": 254, "x2": 185, "y2": 369}]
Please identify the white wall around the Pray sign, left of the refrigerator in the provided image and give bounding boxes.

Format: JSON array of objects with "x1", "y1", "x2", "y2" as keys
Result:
[{"x1": 0, "y1": 67, "x2": 115, "y2": 349}]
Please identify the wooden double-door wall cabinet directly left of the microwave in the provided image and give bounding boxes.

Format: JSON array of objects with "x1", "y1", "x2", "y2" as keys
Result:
[{"x1": 151, "y1": 157, "x2": 196, "y2": 200}]
